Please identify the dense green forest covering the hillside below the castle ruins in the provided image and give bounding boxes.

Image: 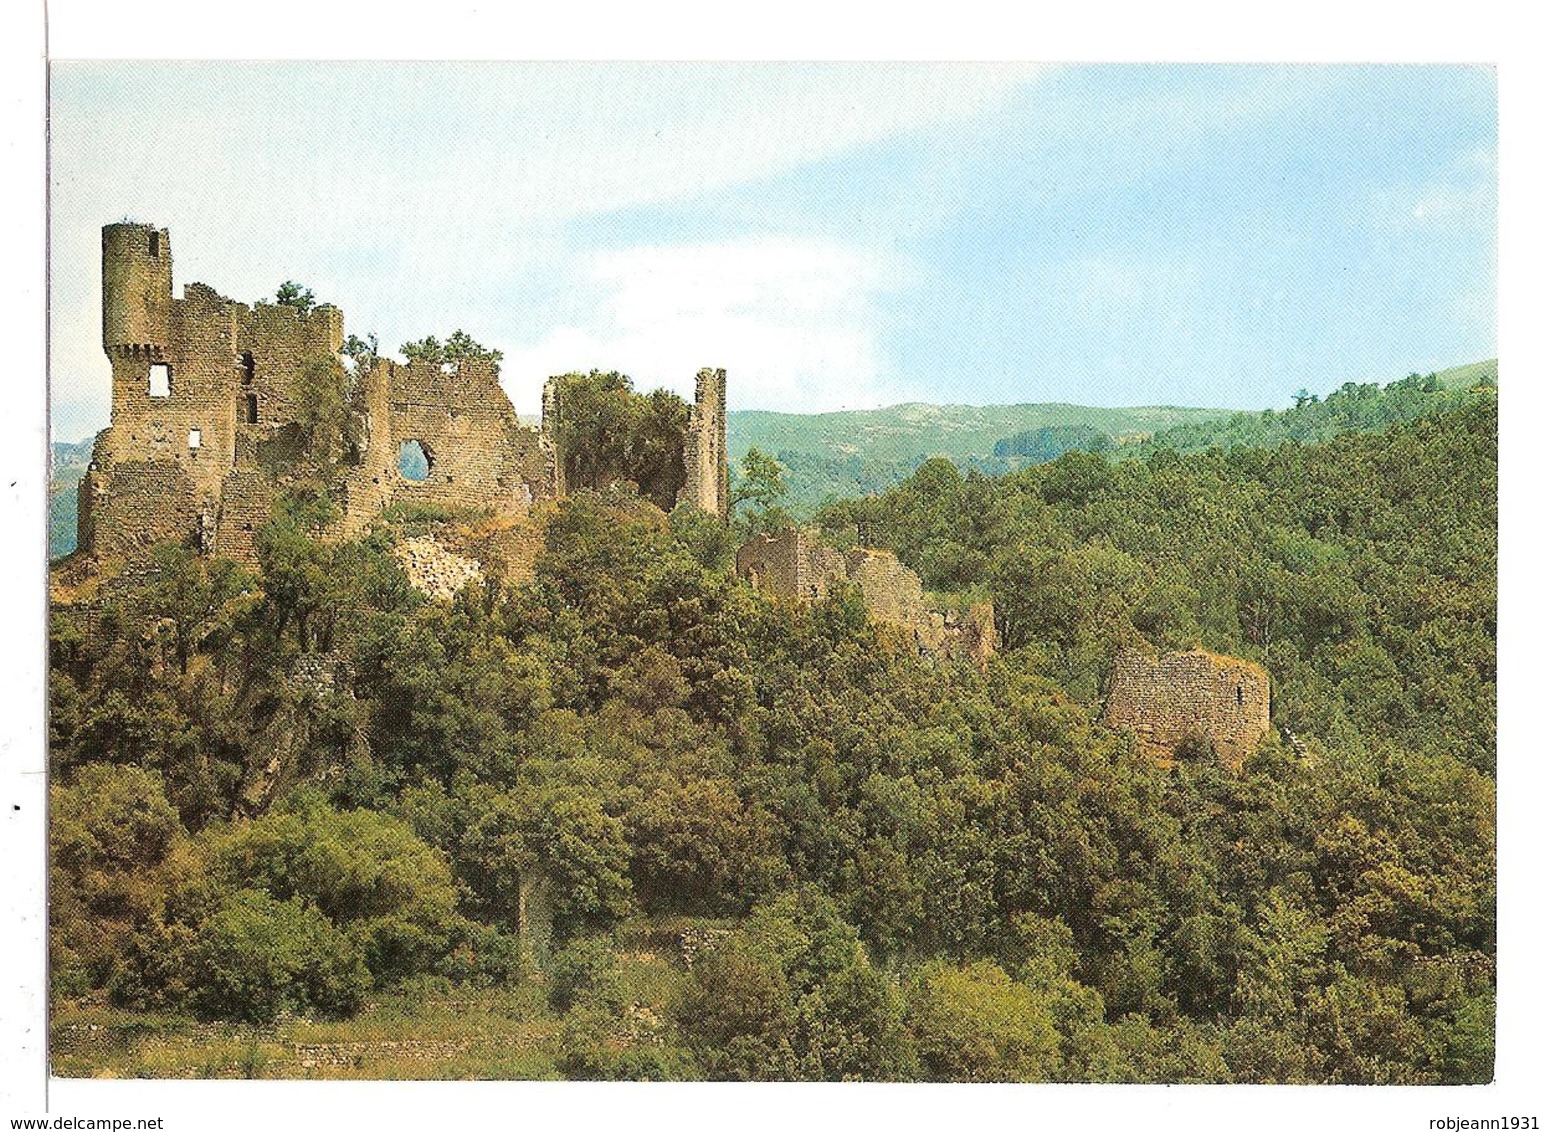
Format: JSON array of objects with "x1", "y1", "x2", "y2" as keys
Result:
[{"x1": 50, "y1": 388, "x2": 1496, "y2": 1084}]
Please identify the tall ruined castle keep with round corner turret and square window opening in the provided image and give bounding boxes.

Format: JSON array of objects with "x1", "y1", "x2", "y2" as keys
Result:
[{"x1": 88, "y1": 225, "x2": 354, "y2": 561}]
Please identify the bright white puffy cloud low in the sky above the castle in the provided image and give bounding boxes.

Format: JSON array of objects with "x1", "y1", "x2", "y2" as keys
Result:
[{"x1": 502, "y1": 237, "x2": 904, "y2": 412}]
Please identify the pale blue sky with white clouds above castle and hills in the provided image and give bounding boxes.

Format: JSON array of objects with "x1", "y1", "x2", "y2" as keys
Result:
[{"x1": 51, "y1": 62, "x2": 1496, "y2": 439}]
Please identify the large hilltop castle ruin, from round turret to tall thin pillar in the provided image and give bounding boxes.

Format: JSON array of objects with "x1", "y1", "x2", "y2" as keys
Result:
[{"x1": 78, "y1": 223, "x2": 729, "y2": 563}]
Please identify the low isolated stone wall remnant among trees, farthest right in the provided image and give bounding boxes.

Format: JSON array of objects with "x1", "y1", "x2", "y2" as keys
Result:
[{"x1": 1104, "y1": 648, "x2": 1269, "y2": 766}]
